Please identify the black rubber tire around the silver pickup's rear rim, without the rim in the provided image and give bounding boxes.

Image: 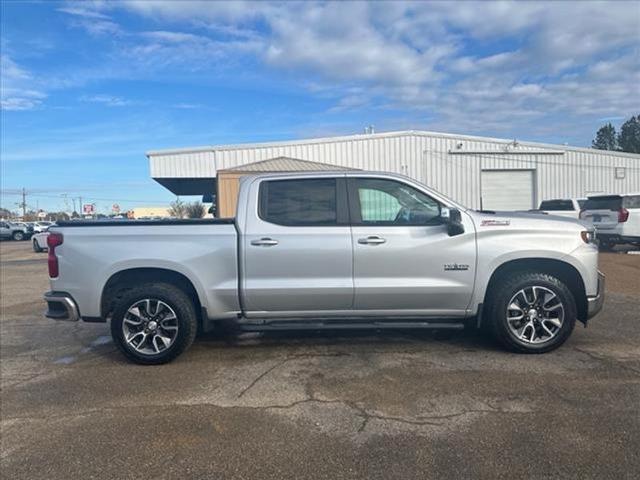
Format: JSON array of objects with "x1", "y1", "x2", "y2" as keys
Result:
[{"x1": 111, "y1": 283, "x2": 198, "y2": 365}]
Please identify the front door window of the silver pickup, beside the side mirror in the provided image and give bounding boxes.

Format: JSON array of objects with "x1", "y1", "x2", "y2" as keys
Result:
[{"x1": 351, "y1": 178, "x2": 440, "y2": 225}]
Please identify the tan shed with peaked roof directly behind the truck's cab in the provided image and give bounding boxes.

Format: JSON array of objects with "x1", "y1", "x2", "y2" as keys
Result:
[{"x1": 216, "y1": 157, "x2": 357, "y2": 218}]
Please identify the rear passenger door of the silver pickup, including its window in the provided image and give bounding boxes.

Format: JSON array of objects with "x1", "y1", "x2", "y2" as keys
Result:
[{"x1": 242, "y1": 177, "x2": 353, "y2": 317}]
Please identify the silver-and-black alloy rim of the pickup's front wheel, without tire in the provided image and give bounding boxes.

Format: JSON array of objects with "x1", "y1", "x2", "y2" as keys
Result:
[{"x1": 507, "y1": 286, "x2": 564, "y2": 344}]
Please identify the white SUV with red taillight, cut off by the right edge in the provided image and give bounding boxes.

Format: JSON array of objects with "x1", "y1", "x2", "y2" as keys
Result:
[{"x1": 580, "y1": 193, "x2": 640, "y2": 250}]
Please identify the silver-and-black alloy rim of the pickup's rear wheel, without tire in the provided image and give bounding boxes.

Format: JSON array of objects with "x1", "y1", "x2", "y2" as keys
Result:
[{"x1": 122, "y1": 298, "x2": 178, "y2": 355}]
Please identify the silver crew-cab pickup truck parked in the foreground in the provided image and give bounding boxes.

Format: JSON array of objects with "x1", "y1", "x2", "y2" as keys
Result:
[{"x1": 45, "y1": 172, "x2": 604, "y2": 364}]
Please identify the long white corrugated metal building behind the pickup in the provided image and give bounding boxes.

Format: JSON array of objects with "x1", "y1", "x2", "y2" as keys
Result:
[{"x1": 147, "y1": 131, "x2": 640, "y2": 210}]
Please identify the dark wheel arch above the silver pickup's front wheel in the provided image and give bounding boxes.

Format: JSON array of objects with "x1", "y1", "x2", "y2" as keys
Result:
[{"x1": 484, "y1": 258, "x2": 588, "y2": 323}]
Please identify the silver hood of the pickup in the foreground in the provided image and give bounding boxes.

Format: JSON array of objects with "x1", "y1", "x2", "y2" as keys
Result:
[{"x1": 467, "y1": 210, "x2": 593, "y2": 231}]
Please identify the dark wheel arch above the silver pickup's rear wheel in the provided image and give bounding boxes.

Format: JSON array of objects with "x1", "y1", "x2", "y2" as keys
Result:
[{"x1": 100, "y1": 267, "x2": 203, "y2": 325}]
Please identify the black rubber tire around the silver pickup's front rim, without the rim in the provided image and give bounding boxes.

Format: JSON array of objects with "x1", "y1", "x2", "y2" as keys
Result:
[{"x1": 486, "y1": 272, "x2": 577, "y2": 353}]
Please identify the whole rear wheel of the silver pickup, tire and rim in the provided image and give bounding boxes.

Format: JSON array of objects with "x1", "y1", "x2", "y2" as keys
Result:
[{"x1": 111, "y1": 283, "x2": 198, "y2": 365}]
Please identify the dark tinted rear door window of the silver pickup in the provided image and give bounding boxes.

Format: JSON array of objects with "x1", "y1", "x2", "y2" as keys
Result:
[{"x1": 260, "y1": 178, "x2": 337, "y2": 226}]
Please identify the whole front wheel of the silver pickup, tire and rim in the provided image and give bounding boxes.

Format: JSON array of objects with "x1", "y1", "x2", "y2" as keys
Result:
[{"x1": 487, "y1": 273, "x2": 577, "y2": 353}]
